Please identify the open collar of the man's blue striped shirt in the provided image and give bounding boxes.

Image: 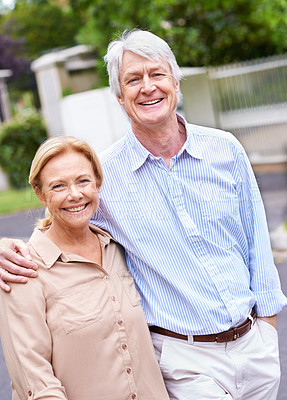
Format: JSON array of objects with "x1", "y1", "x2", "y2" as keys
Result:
[{"x1": 127, "y1": 114, "x2": 203, "y2": 171}]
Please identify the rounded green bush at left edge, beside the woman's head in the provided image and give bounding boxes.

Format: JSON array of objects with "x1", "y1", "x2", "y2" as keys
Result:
[{"x1": 0, "y1": 111, "x2": 47, "y2": 189}]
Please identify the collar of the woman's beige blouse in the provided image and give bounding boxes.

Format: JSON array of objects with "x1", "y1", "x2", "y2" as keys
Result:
[{"x1": 29, "y1": 224, "x2": 113, "y2": 269}]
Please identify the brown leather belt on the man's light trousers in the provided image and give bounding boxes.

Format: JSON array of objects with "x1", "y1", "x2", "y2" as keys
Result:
[{"x1": 149, "y1": 310, "x2": 256, "y2": 343}]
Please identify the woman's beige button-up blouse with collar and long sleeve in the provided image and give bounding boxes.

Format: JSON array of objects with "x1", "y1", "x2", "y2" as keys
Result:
[{"x1": 0, "y1": 226, "x2": 168, "y2": 400}]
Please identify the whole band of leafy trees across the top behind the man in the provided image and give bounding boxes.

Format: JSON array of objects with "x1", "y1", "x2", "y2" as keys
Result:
[{"x1": 0, "y1": 0, "x2": 287, "y2": 98}]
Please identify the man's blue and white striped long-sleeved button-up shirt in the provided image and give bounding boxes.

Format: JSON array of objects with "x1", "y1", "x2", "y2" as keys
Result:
[{"x1": 92, "y1": 116, "x2": 287, "y2": 335}]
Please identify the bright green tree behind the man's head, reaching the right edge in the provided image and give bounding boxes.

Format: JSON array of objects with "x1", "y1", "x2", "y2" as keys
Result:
[{"x1": 75, "y1": 0, "x2": 287, "y2": 70}]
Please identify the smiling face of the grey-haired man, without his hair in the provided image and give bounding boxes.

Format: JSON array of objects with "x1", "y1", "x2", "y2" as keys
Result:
[{"x1": 118, "y1": 51, "x2": 179, "y2": 129}]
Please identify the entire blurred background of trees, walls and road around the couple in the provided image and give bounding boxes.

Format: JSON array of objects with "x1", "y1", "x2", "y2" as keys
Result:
[{"x1": 0, "y1": 0, "x2": 287, "y2": 400}]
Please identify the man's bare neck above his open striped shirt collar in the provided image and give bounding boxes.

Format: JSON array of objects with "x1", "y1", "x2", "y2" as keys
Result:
[{"x1": 132, "y1": 116, "x2": 186, "y2": 167}]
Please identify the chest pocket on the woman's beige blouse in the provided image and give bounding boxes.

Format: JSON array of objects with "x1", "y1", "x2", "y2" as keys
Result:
[{"x1": 52, "y1": 280, "x2": 102, "y2": 334}]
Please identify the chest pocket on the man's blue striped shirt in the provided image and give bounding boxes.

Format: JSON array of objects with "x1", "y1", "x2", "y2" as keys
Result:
[{"x1": 201, "y1": 192, "x2": 242, "y2": 249}]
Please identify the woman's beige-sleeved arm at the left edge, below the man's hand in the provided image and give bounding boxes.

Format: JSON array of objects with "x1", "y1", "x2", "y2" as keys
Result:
[{"x1": 0, "y1": 279, "x2": 67, "y2": 400}]
